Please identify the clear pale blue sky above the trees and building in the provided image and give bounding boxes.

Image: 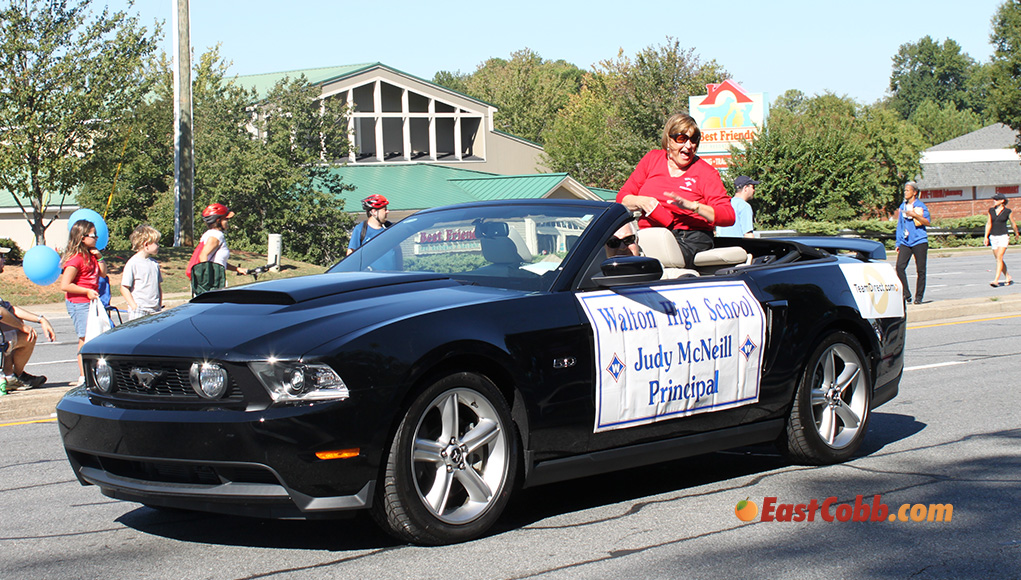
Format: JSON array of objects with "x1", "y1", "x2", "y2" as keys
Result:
[{"x1": 105, "y1": 0, "x2": 1003, "y2": 103}]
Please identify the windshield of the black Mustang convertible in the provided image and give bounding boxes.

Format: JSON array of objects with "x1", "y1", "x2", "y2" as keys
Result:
[{"x1": 330, "y1": 204, "x2": 602, "y2": 291}]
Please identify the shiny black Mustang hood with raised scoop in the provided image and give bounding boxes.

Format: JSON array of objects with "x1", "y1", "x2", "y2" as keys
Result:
[{"x1": 82, "y1": 273, "x2": 521, "y2": 360}]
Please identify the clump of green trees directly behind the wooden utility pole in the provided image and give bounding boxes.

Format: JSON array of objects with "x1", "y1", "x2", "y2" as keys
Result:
[{"x1": 79, "y1": 49, "x2": 352, "y2": 264}]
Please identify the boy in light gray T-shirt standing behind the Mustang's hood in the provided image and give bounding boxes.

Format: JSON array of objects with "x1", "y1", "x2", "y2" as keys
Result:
[{"x1": 120, "y1": 224, "x2": 163, "y2": 321}]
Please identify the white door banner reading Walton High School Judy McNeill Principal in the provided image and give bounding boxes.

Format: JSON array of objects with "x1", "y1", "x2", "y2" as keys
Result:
[{"x1": 578, "y1": 281, "x2": 766, "y2": 432}]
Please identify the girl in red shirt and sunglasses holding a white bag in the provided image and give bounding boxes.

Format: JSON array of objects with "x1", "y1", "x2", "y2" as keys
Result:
[{"x1": 60, "y1": 220, "x2": 106, "y2": 385}]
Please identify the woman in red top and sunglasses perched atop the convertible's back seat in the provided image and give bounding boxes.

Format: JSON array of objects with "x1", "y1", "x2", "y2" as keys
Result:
[{"x1": 617, "y1": 113, "x2": 734, "y2": 268}]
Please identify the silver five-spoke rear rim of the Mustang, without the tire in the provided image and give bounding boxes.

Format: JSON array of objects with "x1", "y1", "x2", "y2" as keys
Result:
[{"x1": 812, "y1": 342, "x2": 869, "y2": 449}]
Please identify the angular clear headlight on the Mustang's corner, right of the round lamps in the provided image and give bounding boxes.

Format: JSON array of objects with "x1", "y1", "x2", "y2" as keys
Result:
[{"x1": 248, "y1": 360, "x2": 350, "y2": 402}]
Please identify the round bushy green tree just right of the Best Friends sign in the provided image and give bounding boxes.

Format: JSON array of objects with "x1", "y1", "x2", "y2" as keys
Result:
[{"x1": 728, "y1": 94, "x2": 922, "y2": 227}]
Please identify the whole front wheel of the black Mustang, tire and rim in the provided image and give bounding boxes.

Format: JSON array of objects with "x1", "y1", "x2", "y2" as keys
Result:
[{"x1": 372, "y1": 373, "x2": 519, "y2": 545}]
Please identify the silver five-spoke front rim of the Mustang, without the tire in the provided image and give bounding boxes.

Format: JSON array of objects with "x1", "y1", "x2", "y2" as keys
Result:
[{"x1": 410, "y1": 388, "x2": 509, "y2": 525}]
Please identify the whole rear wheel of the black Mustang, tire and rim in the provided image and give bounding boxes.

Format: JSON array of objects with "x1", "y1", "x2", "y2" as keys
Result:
[{"x1": 778, "y1": 331, "x2": 872, "y2": 465}]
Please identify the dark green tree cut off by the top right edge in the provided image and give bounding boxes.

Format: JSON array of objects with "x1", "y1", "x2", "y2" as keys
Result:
[{"x1": 989, "y1": 0, "x2": 1021, "y2": 152}]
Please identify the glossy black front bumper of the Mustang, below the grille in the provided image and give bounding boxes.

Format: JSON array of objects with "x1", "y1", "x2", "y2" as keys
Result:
[{"x1": 57, "y1": 388, "x2": 381, "y2": 519}]
